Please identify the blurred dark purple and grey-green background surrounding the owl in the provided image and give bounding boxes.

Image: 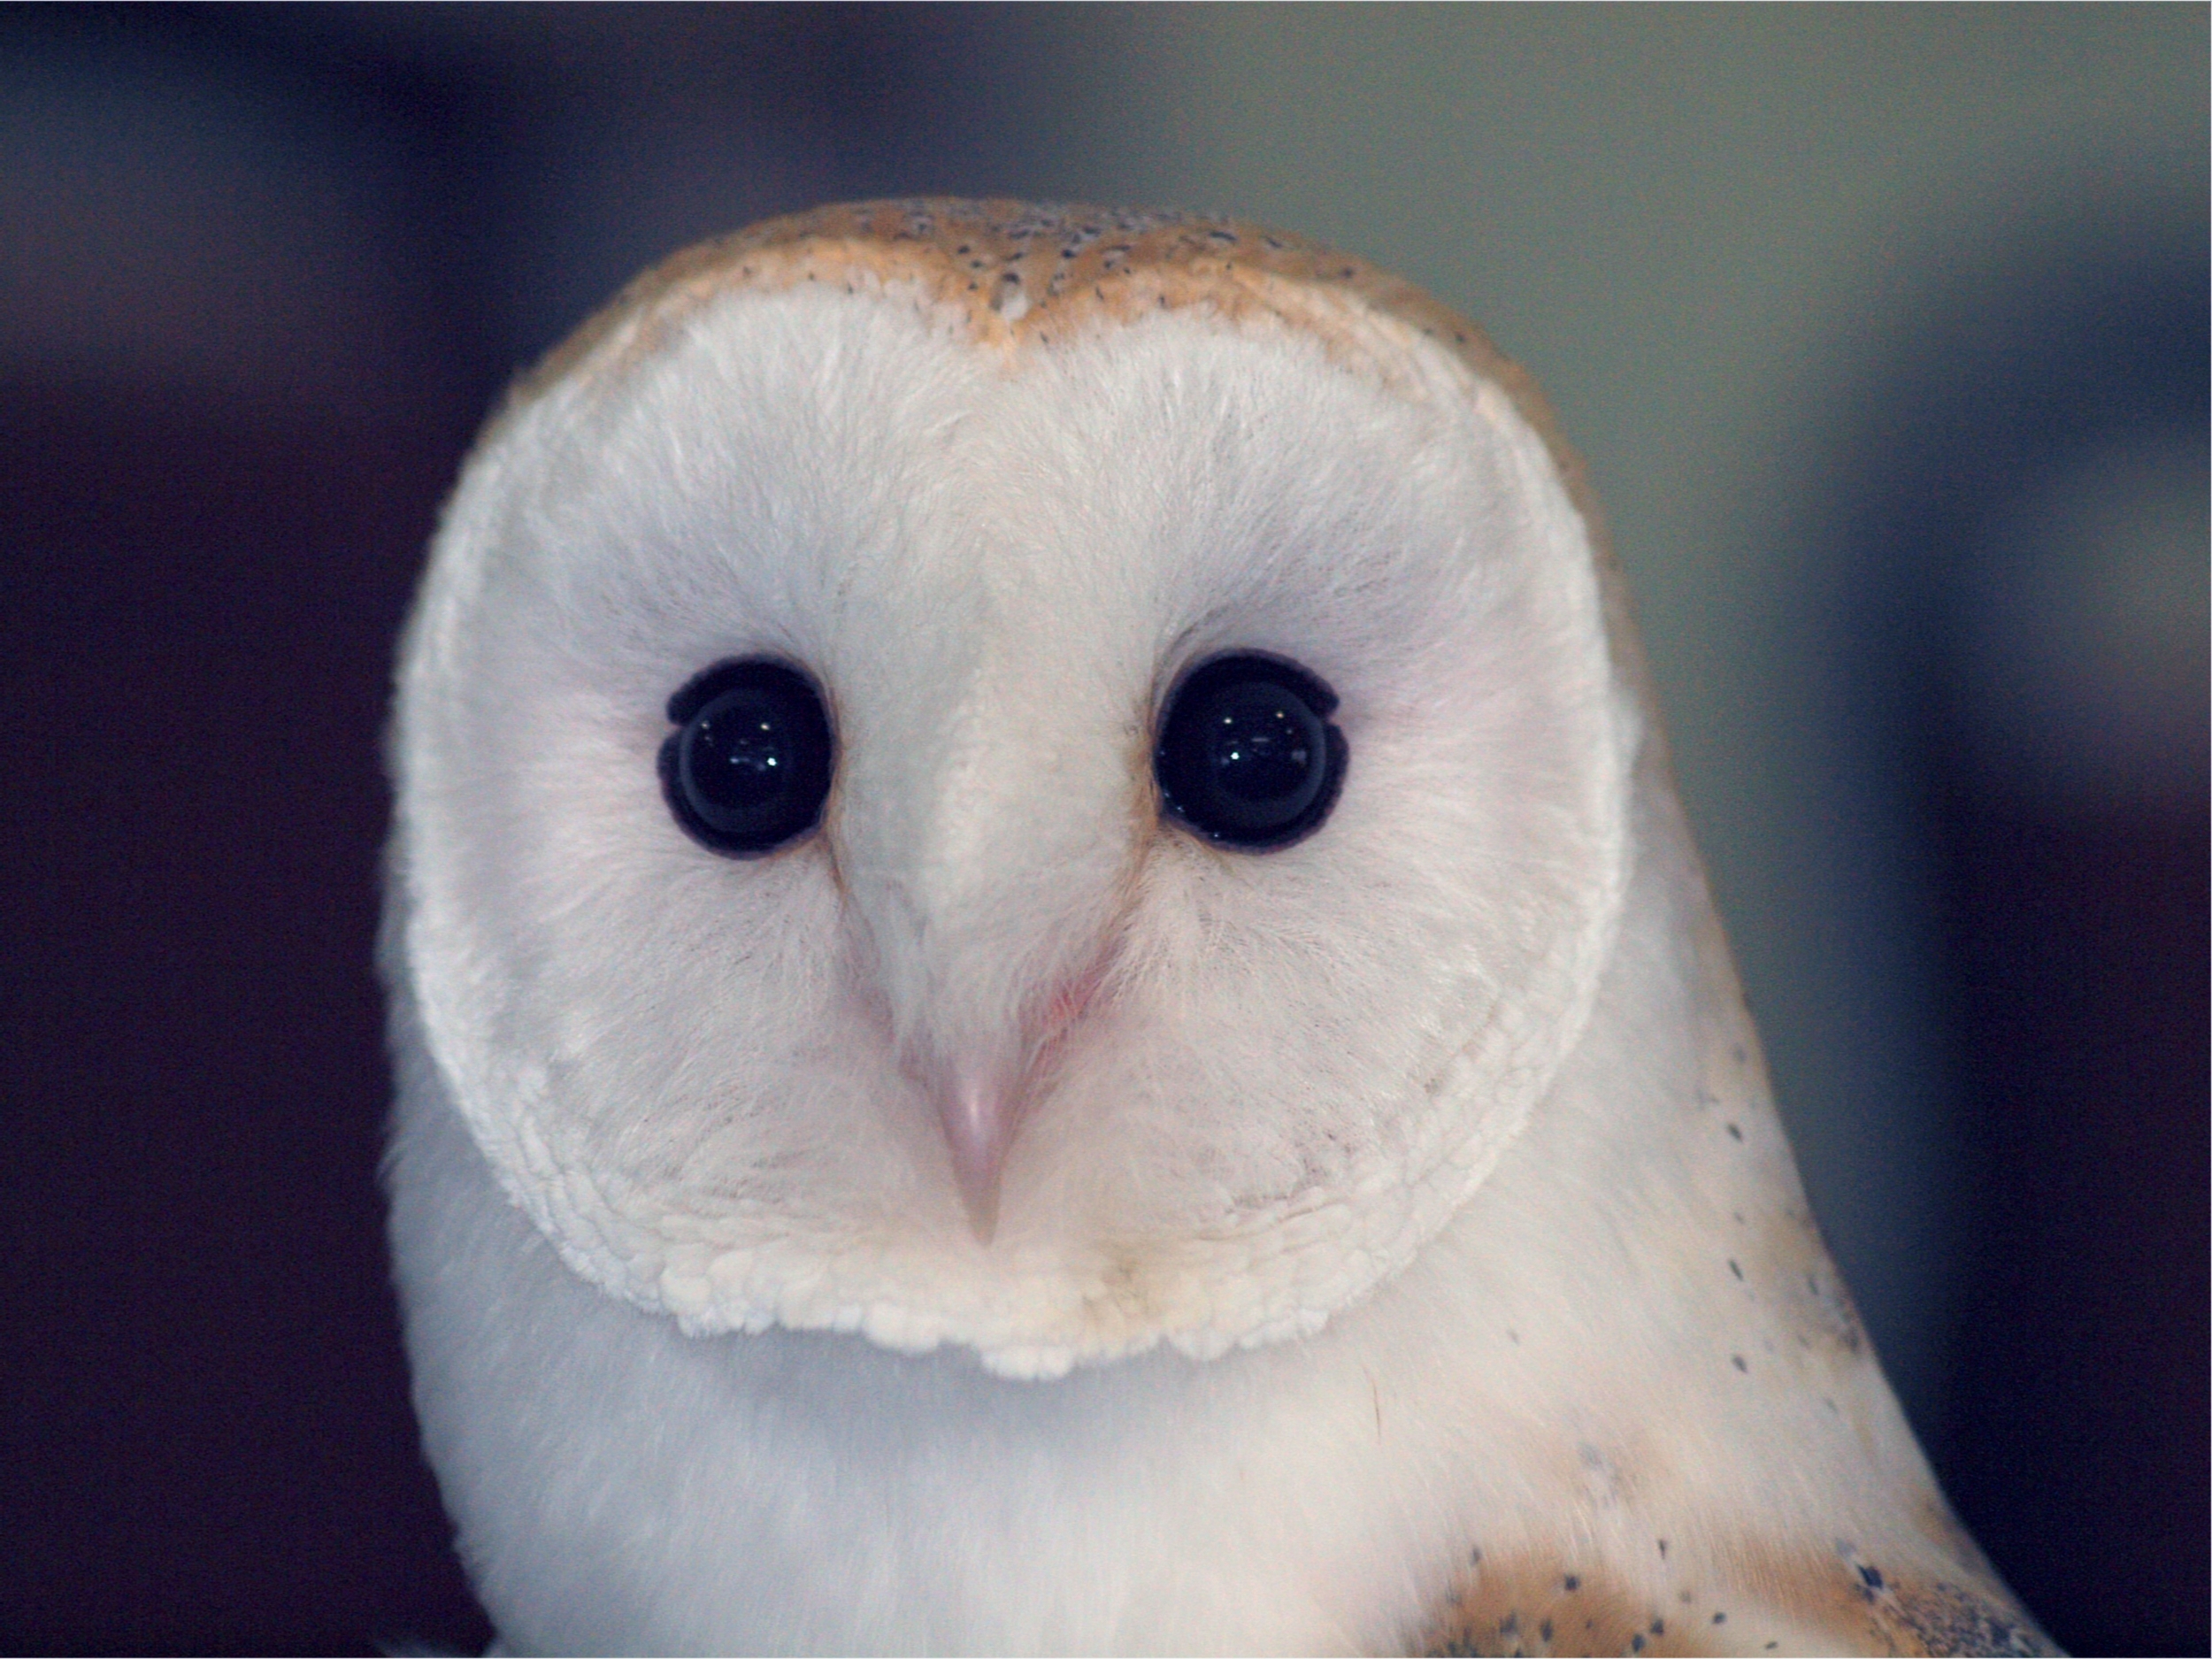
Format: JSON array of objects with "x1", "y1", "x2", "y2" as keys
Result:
[{"x1": 0, "y1": 4, "x2": 2212, "y2": 1653}]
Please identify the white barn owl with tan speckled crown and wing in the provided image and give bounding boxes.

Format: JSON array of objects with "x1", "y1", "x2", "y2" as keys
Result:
[{"x1": 383, "y1": 199, "x2": 2044, "y2": 1655}]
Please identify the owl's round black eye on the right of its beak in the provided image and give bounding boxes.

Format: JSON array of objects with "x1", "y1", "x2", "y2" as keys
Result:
[{"x1": 1153, "y1": 650, "x2": 1349, "y2": 852}]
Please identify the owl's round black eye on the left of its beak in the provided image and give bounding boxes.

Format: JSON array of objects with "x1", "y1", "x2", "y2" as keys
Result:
[{"x1": 662, "y1": 657, "x2": 830, "y2": 858}]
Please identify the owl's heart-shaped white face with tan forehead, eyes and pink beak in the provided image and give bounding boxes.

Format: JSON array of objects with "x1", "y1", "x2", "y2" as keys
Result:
[{"x1": 396, "y1": 204, "x2": 1635, "y2": 1374}]
